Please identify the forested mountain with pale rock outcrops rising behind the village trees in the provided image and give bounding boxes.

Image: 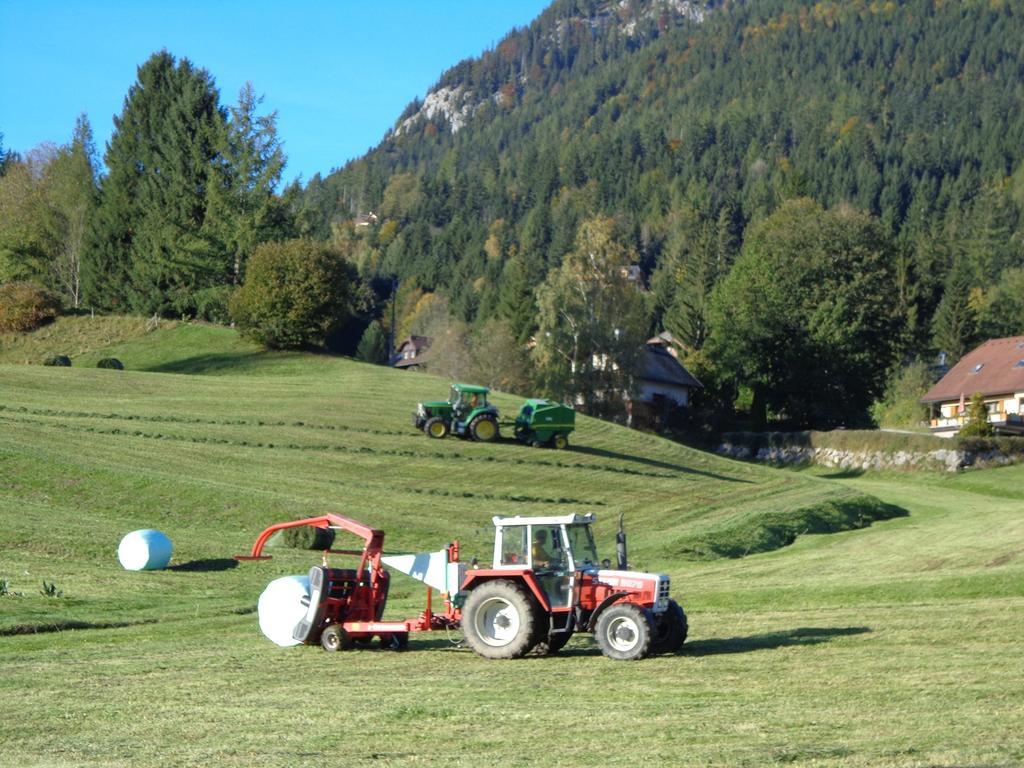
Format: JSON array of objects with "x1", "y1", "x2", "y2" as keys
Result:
[{"x1": 299, "y1": 0, "x2": 1024, "y2": 391}]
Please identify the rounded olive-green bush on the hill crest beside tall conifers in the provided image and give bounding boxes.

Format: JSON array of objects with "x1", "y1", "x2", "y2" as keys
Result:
[{"x1": 228, "y1": 240, "x2": 357, "y2": 349}]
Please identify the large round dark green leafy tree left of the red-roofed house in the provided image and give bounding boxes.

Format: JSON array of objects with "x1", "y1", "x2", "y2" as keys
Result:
[{"x1": 707, "y1": 199, "x2": 898, "y2": 426}]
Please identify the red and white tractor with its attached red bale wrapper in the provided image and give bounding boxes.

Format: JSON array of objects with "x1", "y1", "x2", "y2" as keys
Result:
[{"x1": 241, "y1": 514, "x2": 687, "y2": 659}]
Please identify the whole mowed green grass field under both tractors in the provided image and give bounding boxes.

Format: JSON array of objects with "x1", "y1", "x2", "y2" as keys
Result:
[{"x1": 0, "y1": 326, "x2": 1024, "y2": 766}]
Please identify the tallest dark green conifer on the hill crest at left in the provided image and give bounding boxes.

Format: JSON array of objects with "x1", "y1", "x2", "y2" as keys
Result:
[{"x1": 84, "y1": 50, "x2": 233, "y2": 314}]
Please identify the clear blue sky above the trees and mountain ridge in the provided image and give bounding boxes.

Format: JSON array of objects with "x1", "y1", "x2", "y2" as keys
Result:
[{"x1": 0, "y1": 0, "x2": 550, "y2": 180}]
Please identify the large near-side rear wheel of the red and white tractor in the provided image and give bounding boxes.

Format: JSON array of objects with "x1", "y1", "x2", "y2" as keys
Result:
[{"x1": 462, "y1": 579, "x2": 539, "y2": 658}]
